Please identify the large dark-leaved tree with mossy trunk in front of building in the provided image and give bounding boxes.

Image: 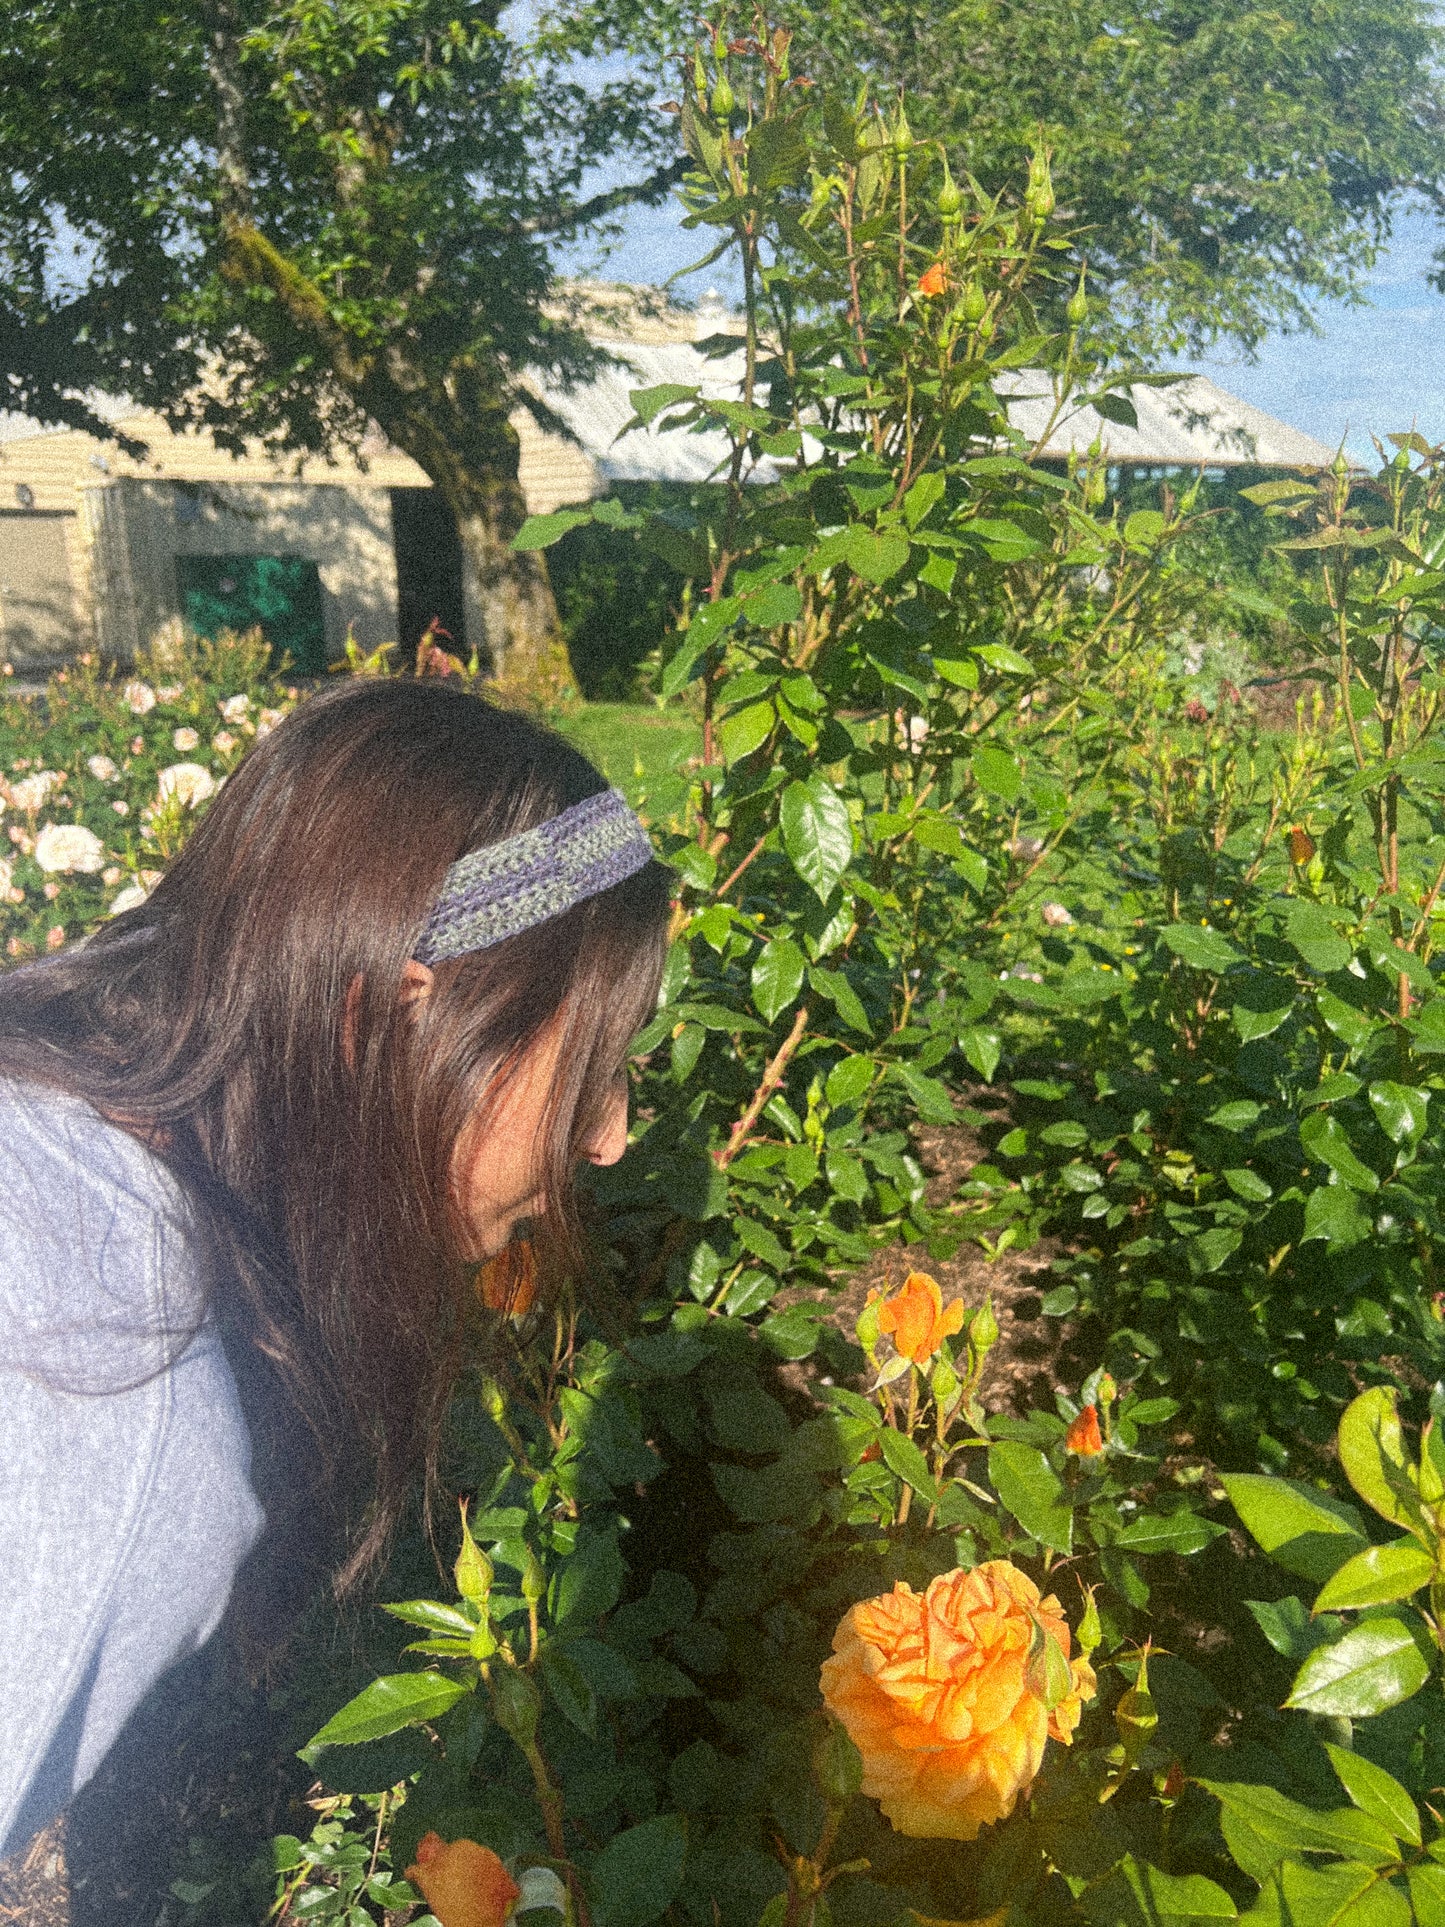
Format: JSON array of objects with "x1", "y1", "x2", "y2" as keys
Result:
[{"x1": 0, "y1": 0, "x2": 672, "y2": 657}]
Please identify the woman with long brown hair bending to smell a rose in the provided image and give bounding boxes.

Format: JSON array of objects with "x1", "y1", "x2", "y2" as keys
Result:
[{"x1": 0, "y1": 682, "x2": 669, "y2": 1854}]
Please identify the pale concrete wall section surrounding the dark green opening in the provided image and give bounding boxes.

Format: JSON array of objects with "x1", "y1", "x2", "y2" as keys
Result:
[{"x1": 81, "y1": 478, "x2": 397, "y2": 661}]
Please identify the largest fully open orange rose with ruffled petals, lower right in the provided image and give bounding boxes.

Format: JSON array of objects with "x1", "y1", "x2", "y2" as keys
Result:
[{"x1": 821, "y1": 1559, "x2": 1094, "y2": 1840}]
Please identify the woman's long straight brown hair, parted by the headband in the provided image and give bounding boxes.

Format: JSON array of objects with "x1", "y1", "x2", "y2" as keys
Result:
[{"x1": 0, "y1": 680, "x2": 669, "y2": 1634}]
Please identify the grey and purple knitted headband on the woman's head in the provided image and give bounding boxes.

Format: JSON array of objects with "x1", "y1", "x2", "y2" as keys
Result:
[{"x1": 412, "y1": 790, "x2": 655, "y2": 964}]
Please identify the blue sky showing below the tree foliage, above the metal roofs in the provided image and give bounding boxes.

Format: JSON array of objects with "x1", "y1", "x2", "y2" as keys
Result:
[{"x1": 578, "y1": 193, "x2": 1445, "y2": 462}]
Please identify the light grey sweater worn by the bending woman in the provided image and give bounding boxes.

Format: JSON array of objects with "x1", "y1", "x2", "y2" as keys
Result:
[{"x1": 0, "y1": 1081, "x2": 264, "y2": 1856}]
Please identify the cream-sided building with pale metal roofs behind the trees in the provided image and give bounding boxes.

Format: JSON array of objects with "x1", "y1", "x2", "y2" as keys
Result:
[{"x1": 0, "y1": 289, "x2": 1333, "y2": 673}]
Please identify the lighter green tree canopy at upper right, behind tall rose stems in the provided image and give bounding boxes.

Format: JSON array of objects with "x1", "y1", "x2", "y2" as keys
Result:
[{"x1": 582, "y1": 0, "x2": 1445, "y2": 356}]
